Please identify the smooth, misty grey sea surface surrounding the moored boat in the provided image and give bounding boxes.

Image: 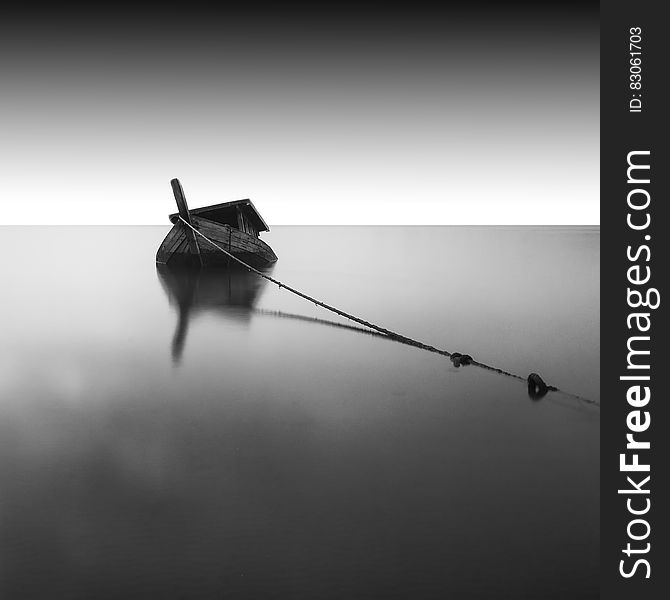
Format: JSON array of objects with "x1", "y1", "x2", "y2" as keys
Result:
[{"x1": 0, "y1": 227, "x2": 600, "y2": 600}]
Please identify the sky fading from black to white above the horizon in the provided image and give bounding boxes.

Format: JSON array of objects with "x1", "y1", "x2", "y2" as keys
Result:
[{"x1": 0, "y1": 3, "x2": 600, "y2": 225}]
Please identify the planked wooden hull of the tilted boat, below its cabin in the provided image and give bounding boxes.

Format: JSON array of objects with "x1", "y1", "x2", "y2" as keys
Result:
[{"x1": 156, "y1": 215, "x2": 277, "y2": 268}]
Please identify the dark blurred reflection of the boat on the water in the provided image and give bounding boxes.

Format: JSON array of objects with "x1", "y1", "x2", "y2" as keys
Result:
[{"x1": 156, "y1": 264, "x2": 272, "y2": 363}]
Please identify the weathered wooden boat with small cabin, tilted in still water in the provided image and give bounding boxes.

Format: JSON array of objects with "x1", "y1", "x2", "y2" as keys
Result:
[{"x1": 156, "y1": 179, "x2": 277, "y2": 268}]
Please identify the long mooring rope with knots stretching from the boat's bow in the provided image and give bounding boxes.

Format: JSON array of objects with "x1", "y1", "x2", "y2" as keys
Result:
[{"x1": 178, "y1": 215, "x2": 600, "y2": 406}]
